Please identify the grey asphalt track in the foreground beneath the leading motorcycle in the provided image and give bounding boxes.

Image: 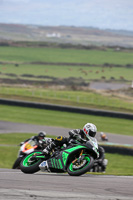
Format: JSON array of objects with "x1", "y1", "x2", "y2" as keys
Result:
[{"x1": 0, "y1": 169, "x2": 133, "y2": 200}]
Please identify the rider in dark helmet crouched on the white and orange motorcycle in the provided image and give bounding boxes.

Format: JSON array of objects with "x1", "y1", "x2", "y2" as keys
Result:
[{"x1": 20, "y1": 131, "x2": 52, "y2": 148}]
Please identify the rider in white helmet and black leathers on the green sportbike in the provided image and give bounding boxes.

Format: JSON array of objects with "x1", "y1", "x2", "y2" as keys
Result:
[{"x1": 43, "y1": 123, "x2": 106, "y2": 171}]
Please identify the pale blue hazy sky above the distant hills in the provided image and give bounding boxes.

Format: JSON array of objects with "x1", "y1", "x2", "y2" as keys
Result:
[{"x1": 0, "y1": 0, "x2": 133, "y2": 31}]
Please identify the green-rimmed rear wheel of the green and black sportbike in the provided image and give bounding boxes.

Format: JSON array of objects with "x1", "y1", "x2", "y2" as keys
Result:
[{"x1": 20, "y1": 152, "x2": 44, "y2": 174}]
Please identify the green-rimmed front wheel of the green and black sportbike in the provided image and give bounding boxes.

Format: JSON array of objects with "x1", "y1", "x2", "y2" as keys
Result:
[{"x1": 67, "y1": 156, "x2": 94, "y2": 176}]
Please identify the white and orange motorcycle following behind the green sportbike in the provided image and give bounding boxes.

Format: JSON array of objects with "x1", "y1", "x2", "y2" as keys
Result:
[{"x1": 12, "y1": 139, "x2": 44, "y2": 169}]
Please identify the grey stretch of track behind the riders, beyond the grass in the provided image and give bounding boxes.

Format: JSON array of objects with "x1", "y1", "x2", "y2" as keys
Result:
[{"x1": 0, "y1": 121, "x2": 133, "y2": 145}]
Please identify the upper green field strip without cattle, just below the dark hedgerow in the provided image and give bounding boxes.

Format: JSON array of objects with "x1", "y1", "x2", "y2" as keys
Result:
[{"x1": 0, "y1": 47, "x2": 133, "y2": 65}]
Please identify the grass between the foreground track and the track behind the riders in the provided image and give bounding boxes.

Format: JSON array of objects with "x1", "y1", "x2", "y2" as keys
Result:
[{"x1": 0, "y1": 133, "x2": 133, "y2": 175}]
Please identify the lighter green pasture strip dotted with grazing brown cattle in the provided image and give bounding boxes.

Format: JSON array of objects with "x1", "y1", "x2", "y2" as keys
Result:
[{"x1": 0, "y1": 64, "x2": 133, "y2": 82}]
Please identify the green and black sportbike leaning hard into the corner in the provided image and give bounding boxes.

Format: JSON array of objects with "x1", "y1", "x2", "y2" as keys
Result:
[{"x1": 20, "y1": 138, "x2": 99, "y2": 176}]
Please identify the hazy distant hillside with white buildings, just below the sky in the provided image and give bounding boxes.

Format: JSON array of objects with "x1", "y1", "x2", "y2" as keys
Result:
[{"x1": 0, "y1": 24, "x2": 133, "y2": 47}]
